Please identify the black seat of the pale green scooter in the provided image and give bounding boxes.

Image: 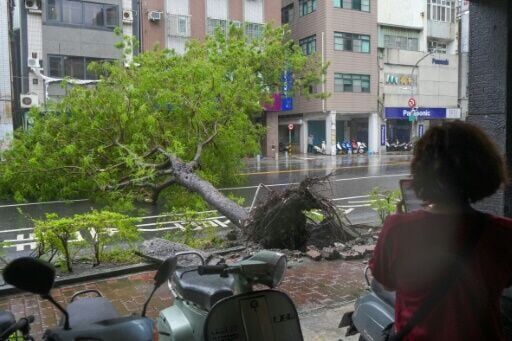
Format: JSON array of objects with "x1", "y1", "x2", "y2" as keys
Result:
[{"x1": 172, "y1": 268, "x2": 235, "y2": 310}]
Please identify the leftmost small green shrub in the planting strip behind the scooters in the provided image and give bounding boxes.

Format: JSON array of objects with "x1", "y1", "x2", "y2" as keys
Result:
[{"x1": 33, "y1": 213, "x2": 79, "y2": 272}]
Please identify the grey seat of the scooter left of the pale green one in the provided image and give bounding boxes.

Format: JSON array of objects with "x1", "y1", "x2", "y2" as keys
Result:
[{"x1": 61, "y1": 297, "x2": 119, "y2": 328}]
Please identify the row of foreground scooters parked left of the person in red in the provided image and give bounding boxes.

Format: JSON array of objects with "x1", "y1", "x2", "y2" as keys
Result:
[{"x1": 0, "y1": 250, "x2": 303, "y2": 341}]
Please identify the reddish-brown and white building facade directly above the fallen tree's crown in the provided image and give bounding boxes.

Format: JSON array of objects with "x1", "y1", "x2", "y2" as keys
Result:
[{"x1": 139, "y1": 0, "x2": 281, "y2": 53}]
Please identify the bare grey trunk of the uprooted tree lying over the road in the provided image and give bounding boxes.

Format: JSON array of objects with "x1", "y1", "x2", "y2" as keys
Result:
[{"x1": 173, "y1": 164, "x2": 249, "y2": 227}]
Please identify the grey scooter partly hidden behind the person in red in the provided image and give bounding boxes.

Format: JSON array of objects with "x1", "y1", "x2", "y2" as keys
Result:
[{"x1": 339, "y1": 267, "x2": 396, "y2": 340}]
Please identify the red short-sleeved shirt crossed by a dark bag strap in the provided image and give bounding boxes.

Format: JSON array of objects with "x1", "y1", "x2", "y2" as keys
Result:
[{"x1": 370, "y1": 210, "x2": 512, "y2": 341}]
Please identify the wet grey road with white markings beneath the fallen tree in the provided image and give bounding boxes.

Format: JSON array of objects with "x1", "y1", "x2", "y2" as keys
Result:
[{"x1": 0, "y1": 155, "x2": 411, "y2": 253}]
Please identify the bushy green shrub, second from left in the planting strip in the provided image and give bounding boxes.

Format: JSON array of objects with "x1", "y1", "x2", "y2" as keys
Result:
[{"x1": 72, "y1": 210, "x2": 140, "y2": 265}]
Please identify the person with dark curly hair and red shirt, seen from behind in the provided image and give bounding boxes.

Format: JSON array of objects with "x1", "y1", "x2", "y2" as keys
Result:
[{"x1": 370, "y1": 121, "x2": 512, "y2": 340}]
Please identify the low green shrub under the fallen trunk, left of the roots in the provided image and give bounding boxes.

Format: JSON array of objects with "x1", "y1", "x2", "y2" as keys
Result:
[{"x1": 164, "y1": 210, "x2": 224, "y2": 249}]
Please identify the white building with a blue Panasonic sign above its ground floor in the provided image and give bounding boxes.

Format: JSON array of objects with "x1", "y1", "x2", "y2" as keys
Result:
[{"x1": 378, "y1": 0, "x2": 461, "y2": 146}]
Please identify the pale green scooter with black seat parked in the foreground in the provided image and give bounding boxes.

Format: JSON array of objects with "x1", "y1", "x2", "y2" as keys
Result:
[{"x1": 158, "y1": 251, "x2": 303, "y2": 341}]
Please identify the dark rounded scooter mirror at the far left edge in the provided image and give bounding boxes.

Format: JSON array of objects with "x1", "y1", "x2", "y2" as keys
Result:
[{"x1": 3, "y1": 257, "x2": 55, "y2": 296}]
